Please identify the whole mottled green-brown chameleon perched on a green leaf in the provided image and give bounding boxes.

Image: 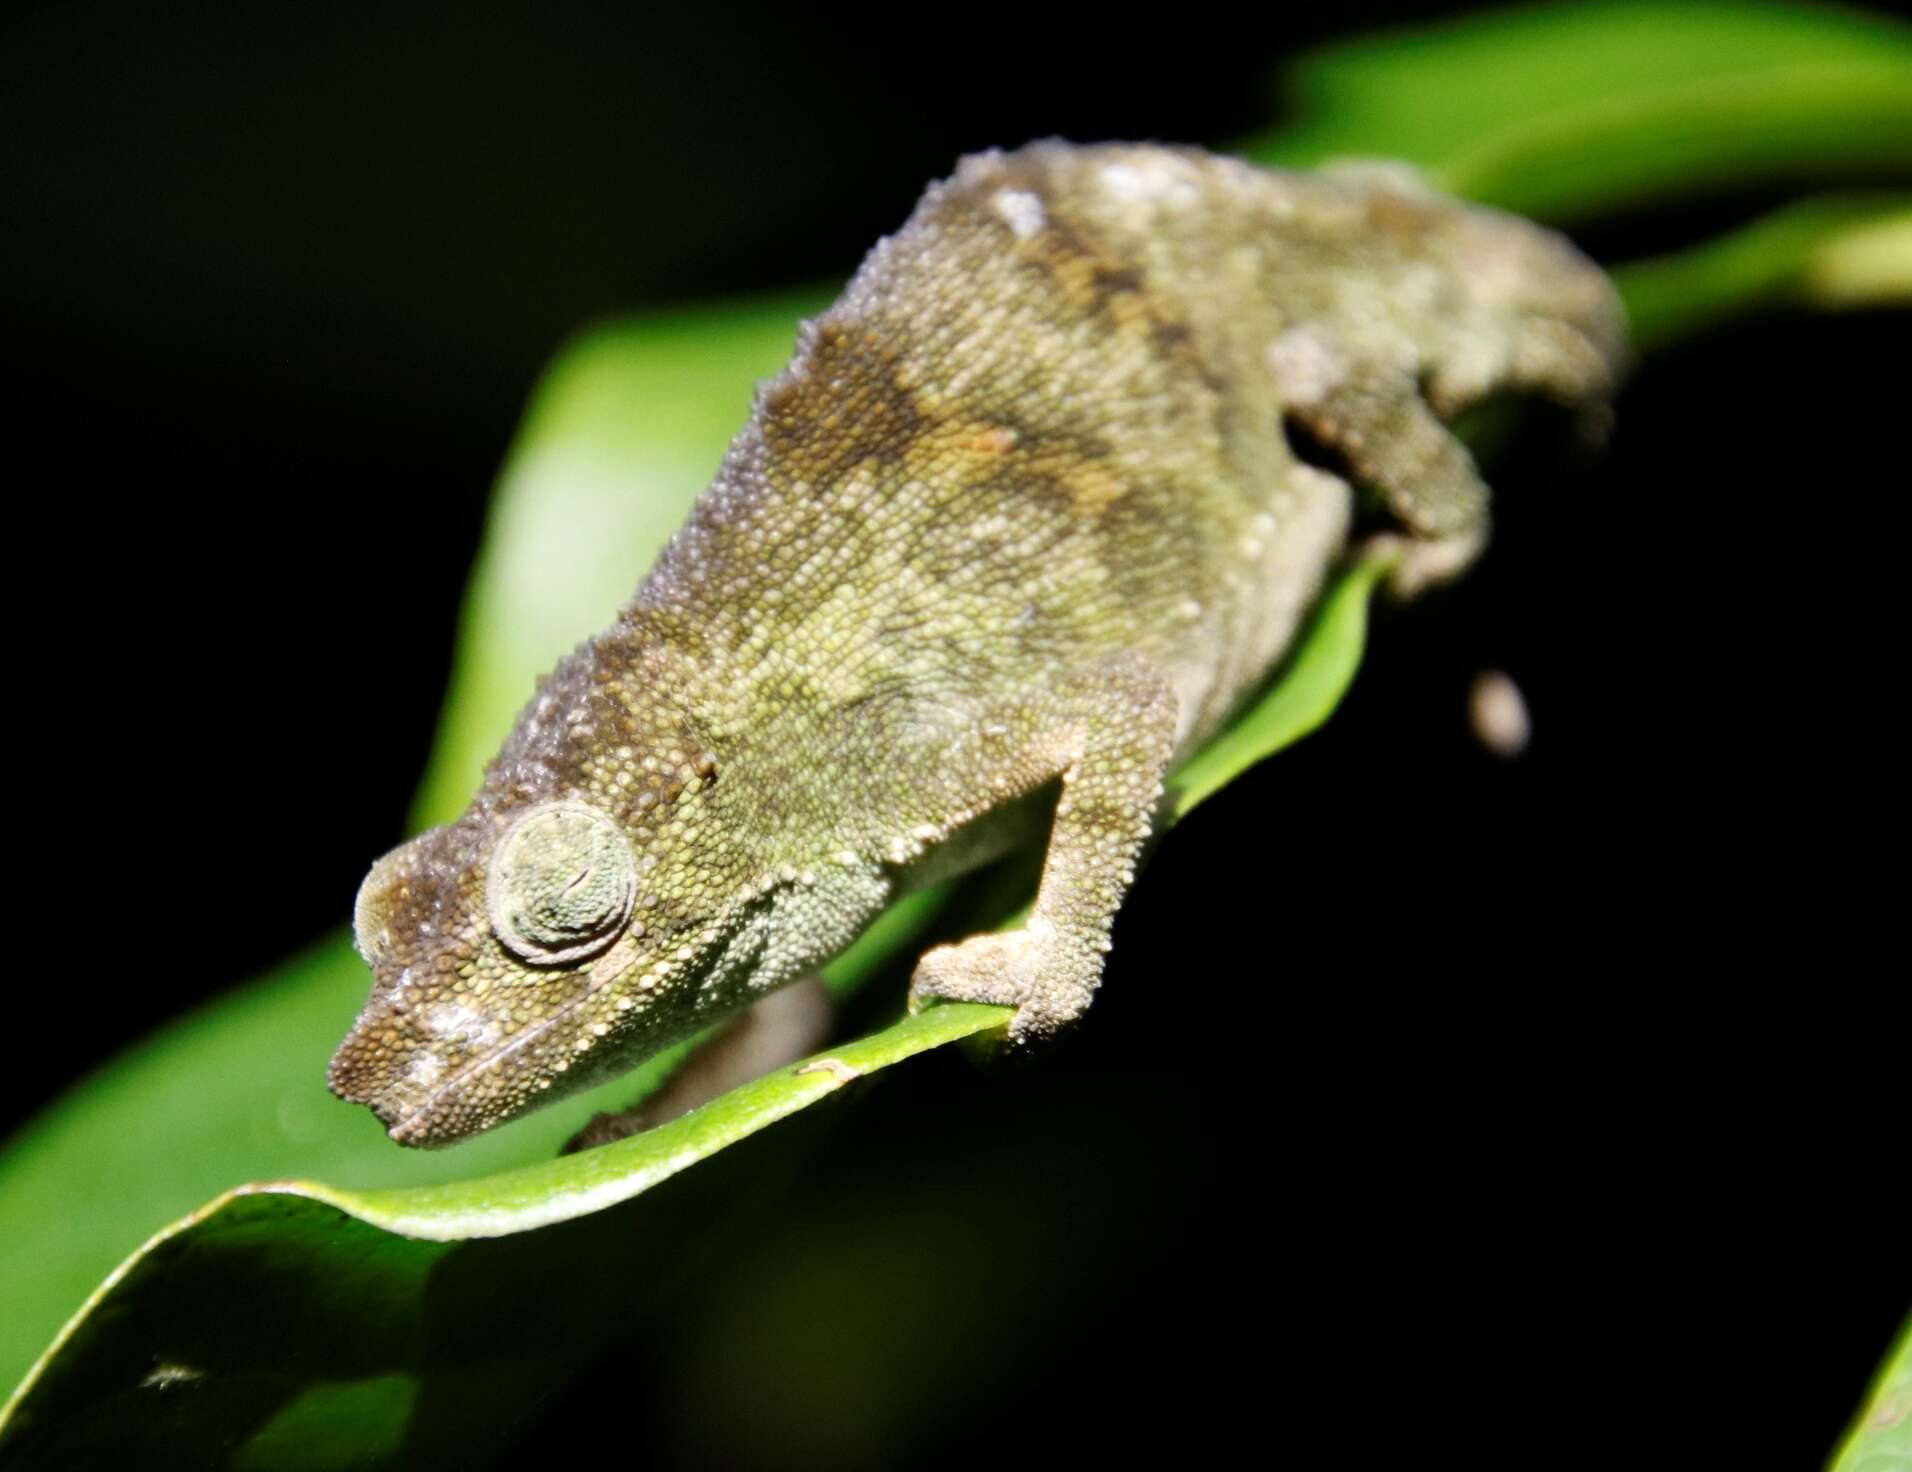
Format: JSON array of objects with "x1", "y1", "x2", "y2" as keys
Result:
[{"x1": 331, "y1": 141, "x2": 1625, "y2": 1145}]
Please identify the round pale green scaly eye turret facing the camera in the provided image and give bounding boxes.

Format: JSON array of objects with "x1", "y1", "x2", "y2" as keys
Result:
[{"x1": 486, "y1": 803, "x2": 637, "y2": 965}]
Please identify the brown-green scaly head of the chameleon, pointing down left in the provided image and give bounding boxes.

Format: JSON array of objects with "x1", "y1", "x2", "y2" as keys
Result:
[{"x1": 329, "y1": 630, "x2": 748, "y2": 1145}]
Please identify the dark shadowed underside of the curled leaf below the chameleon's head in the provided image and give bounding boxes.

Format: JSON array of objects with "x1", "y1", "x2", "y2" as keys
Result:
[{"x1": 0, "y1": 1093, "x2": 860, "y2": 1472}]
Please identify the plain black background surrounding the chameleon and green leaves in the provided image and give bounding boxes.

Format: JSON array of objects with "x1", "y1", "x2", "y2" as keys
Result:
[{"x1": 0, "y1": 4, "x2": 1912, "y2": 1466}]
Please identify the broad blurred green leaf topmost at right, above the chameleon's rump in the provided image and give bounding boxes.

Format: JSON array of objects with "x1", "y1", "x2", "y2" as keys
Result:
[{"x1": 1247, "y1": 0, "x2": 1912, "y2": 220}]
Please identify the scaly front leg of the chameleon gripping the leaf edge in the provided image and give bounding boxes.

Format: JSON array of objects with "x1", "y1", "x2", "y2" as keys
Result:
[{"x1": 910, "y1": 658, "x2": 1178, "y2": 1042}]
